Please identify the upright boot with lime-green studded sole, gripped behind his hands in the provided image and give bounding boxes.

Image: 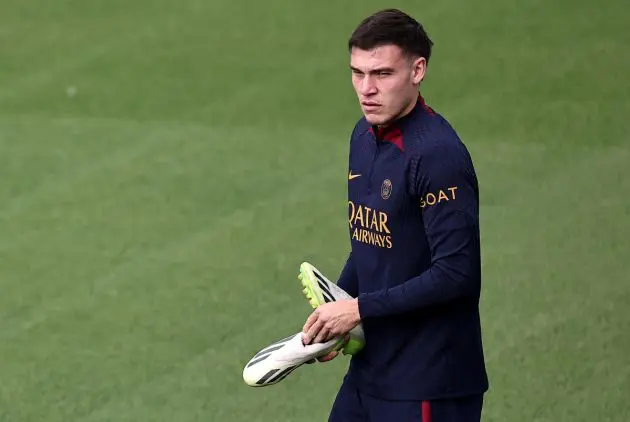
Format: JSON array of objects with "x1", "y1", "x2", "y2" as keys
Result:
[{"x1": 298, "y1": 262, "x2": 365, "y2": 355}]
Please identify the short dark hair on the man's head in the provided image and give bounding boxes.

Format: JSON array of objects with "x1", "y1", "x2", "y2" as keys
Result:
[{"x1": 348, "y1": 9, "x2": 433, "y2": 63}]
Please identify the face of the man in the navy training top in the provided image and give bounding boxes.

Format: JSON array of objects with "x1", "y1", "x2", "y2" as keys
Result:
[{"x1": 350, "y1": 45, "x2": 426, "y2": 125}]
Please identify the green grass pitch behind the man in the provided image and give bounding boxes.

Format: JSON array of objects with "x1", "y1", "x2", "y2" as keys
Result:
[{"x1": 0, "y1": 0, "x2": 630, "y2": 422}]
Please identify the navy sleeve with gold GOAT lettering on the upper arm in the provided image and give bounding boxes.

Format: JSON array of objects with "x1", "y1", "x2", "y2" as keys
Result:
[{"x1": 359, "y1": 142, "x2": 481, "y2": 318}]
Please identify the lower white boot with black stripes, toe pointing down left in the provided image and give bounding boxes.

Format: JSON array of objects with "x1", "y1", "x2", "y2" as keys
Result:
[{"x1": 243, "y1": 332, "x2": 344, "y2": 387}]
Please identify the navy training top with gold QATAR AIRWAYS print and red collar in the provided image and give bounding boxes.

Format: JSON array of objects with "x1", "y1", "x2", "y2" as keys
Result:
[{"x1": 338, "y1": 97, "x2": 488, "y2": 400}]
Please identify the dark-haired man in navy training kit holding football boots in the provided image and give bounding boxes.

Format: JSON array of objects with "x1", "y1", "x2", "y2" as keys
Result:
[{"x1": 303, "y1": 9, "x2": 488, "y2": 422}]
